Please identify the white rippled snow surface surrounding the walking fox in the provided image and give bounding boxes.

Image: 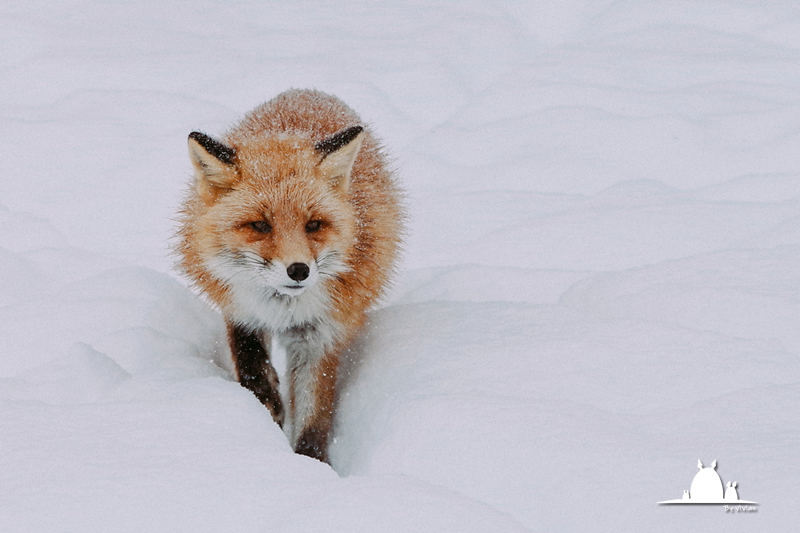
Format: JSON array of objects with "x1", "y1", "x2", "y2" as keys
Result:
[{"x1": 0, "y1": 0, "x2": 800, "y2": 532}]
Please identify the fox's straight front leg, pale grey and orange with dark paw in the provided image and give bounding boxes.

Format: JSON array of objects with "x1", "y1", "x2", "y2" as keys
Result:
[{"x1": 283, "y1": 326, "x2": 339, "y2": 463}]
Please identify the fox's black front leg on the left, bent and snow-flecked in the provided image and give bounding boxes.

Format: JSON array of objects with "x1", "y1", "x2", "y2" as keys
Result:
[{"x1": 228, "y1": 322, "x2": 284, "y2": 427}]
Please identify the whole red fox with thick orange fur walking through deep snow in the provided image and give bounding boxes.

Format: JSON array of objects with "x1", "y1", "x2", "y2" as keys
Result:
[{"x1": 177, "y1": 90, "x2": 404, "y2": 462}]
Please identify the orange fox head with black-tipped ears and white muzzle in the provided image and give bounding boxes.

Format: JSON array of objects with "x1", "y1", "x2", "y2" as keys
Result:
[{"x1": 189, "y1": 126, "x2": 364, "y2": 299}]
